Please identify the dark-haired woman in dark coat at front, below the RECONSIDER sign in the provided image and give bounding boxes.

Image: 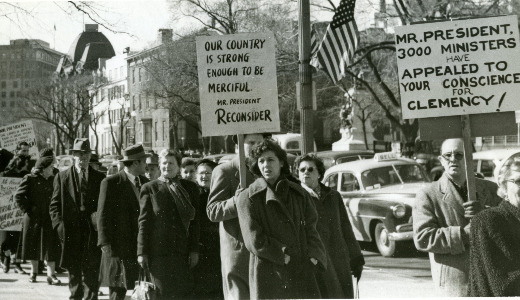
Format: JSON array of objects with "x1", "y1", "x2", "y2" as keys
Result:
[{"x1": 236, "y1": 140, "x2": 327, "y2": 299}]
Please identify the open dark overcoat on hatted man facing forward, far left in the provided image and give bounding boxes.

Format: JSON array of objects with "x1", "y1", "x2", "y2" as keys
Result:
[{"x1": 49, "y1": 166, "x2": 105, "y2": 268}]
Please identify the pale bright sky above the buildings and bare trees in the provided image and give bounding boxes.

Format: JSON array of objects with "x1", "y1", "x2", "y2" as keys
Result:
[{"x1": 0, "y1": 0, "x2": 379, "y2": 53}]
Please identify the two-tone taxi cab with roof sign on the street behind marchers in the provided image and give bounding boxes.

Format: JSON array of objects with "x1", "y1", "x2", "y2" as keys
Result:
[{"x1": 323, "y1": 152, "x2": 430, "y2": 257}]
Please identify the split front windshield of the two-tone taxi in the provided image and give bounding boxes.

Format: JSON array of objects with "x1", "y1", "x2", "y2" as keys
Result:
[{"x1": 361, "y1": 165, "x2": 428, "y2": 190}]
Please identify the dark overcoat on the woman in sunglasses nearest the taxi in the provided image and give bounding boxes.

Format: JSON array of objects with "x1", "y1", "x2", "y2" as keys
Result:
[{"x1": 313, "y1": 184, "x2": 365, "y2": 299}]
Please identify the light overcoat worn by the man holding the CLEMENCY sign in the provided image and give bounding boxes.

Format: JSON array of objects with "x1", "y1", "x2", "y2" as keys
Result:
[{"x1": 412, "y1": 174, "x2": 501, "y2": 297}]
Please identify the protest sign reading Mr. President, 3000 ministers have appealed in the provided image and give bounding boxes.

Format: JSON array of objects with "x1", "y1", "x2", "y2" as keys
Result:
[{"x1": 395, "y1": 16, "x2": 520, "y2": 119}]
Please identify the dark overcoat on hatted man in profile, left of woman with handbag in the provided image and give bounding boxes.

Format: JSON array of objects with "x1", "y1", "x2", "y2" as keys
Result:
[{"x1": 97, "y1": 170, "x2": 148, "y2": 289}]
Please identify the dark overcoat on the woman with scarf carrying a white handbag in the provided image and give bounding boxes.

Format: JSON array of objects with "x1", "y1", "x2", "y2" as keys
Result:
[{"x1": 137, "y1": 178, "x2": 200, "y2": 297}]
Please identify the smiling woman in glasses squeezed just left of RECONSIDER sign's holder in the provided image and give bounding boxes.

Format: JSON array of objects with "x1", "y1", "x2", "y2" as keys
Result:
[{"x1": 193, "y1": 159, "x2": 224, "y2": 299}]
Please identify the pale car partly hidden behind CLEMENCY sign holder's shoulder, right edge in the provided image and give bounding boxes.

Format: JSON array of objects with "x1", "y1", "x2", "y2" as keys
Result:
[{"x1": 473, "y1": 148, "x2": 520, "y2": 182}]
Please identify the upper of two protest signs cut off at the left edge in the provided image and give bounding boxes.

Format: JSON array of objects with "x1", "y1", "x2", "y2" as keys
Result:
[{"x1": 0, "y1": 120, "x2": 39, "y2": 159}]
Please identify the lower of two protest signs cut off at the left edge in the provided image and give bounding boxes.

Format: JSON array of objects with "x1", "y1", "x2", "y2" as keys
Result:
[{"x1": 0, "y1": 177, "x2": 23, "y2": 231}]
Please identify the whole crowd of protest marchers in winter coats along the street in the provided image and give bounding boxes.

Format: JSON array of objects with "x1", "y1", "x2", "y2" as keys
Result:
[{"x1": 0, "y1": 134, "x2": 520, "y2": 299}]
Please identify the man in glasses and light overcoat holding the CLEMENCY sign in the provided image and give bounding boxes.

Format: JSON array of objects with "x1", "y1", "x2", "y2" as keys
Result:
[{"x1": 412, "y1": 139, "x2": 501, "y2": 297}]
